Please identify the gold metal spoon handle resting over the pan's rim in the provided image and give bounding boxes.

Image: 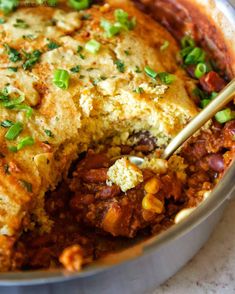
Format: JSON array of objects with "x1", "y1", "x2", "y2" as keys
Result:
[{"x1": 162, "y1": 78, "x2": 235, "y2": 159}]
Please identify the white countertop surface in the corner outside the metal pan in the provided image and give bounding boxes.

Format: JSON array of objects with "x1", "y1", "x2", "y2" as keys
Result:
[{"x1": 156, "y1": 200, "x2": 235, "y2": 294}]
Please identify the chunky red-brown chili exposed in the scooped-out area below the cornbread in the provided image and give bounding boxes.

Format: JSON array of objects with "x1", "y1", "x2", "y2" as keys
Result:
[{"x1": 13, "y1": 121, "x2": 235, "y2": 271}]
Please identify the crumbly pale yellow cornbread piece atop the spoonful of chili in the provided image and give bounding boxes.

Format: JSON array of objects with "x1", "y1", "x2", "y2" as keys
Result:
[{"x1": 108, "y1": 158, "x2": 143, "y2": 192}]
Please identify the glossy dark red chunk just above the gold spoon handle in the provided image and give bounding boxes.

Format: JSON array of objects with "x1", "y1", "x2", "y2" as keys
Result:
[{"x1": 199, "y1": 71, "x2": 225, "y2": 92}]
